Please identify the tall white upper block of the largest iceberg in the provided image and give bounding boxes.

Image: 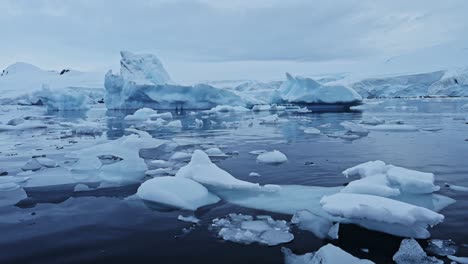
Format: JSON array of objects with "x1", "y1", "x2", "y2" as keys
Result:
[{"x1": 120, "y1": 51, "x2": 173, "y2": 85}]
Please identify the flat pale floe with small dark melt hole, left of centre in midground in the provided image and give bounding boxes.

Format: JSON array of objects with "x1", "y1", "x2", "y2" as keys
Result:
[{"x1": 66, "y1": 129, "x2": 164, "y2": 184}]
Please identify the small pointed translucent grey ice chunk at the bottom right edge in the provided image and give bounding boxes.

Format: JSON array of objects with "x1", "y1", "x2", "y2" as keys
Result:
[{"x1": 393, "y1": 239, "x2": 444, "y2": 264}]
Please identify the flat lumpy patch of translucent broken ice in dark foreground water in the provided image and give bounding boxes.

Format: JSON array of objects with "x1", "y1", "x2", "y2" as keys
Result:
[{"x1": 211, "y1": 214, "x2": 294, "y2": 246}]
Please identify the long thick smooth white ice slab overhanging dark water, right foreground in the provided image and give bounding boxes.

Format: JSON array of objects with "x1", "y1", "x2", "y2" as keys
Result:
[{"x1": 320, "y1": 193, "x2": 444, "y2": 238}]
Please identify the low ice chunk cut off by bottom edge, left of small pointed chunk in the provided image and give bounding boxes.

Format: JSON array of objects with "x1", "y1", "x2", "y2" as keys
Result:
[{"x1": 281, "y1": 244, "x2": 374, "y2": 264}]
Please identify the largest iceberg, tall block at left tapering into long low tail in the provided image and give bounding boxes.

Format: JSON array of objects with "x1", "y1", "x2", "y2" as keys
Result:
[{"x1": 104, "y1": 51, "x2": 250, "y2": 109}]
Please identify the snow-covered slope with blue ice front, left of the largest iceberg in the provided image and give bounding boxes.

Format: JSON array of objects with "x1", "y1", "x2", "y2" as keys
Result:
[{"x1": 0, "y1": 62, "x2": 104, "y2": 105}]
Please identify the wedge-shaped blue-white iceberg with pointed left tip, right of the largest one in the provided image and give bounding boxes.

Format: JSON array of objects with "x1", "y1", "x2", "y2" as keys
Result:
[{"x1": 272, "y1": 73, "x2": 362, "y2": 105}]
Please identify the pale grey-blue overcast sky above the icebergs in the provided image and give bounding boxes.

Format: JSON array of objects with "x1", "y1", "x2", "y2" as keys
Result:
[{"x1": 0, "y1": 0, "x2": 468, "y2": 82}]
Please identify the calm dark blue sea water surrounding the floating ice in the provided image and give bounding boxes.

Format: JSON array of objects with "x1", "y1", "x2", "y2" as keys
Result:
[{"x1": 0, "y1": 99, "x2": 468, "y2": 263}]
